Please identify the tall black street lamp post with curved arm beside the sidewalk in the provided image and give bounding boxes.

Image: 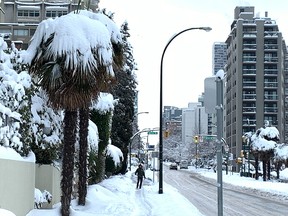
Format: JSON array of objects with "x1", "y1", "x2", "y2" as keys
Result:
[{"x1": 159, "y1": 27, "x2": 212, "y2": 194}]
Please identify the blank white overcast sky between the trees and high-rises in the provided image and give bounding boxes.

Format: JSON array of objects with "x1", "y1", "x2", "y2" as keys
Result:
[{"x1": 99, "y1": 0, "x2": 288, "y2": 129}]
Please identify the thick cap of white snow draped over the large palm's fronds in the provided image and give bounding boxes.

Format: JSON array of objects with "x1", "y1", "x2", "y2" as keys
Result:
[{"x1": 24, "y1": 13, "x2": 113, "y2": 73}]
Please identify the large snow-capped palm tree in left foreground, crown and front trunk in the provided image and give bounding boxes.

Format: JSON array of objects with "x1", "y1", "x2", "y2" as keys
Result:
[{"x1": 23, "y1": 12, "x2": 121, "y2": 216}]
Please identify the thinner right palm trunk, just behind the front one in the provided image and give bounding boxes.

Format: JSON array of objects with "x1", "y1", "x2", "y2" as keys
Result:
[{"x1": 78, "y1": 108, "x2": 89, "y2": 205}]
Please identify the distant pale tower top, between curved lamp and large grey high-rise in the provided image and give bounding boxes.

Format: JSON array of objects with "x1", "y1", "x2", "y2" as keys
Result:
[{"x1": 212, "y1": 42, "x2": 227, "y2": 75}]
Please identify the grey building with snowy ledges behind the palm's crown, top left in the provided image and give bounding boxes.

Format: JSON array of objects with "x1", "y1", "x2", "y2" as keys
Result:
[{"x1": 0, "y1": 0, "x2": 99, "y2": 49}]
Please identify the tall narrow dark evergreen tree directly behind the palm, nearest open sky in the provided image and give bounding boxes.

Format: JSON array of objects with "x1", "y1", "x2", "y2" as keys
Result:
[{"x1": 111, "y1": 22, "x2": 137, "y2": 174}]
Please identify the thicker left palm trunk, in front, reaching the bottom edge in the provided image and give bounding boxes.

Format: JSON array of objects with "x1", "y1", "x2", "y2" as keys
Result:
[{"x1": 61, "y1": 110, "x2": 77, "y2": 216}]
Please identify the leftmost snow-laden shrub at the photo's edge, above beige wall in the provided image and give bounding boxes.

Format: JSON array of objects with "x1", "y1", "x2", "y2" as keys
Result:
[{"x1": 0, "y1": 37, "x2": 33, "y2": 156}]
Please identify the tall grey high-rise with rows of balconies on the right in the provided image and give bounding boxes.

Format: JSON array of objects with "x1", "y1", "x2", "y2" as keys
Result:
[{"x1": 224, "y1": 7, "x2": 287, "y2": 157}]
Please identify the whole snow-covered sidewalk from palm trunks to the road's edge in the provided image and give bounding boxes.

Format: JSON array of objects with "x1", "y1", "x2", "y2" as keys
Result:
[{"x1": 27, "y1": 169, "x2": 202, "y2": 216}]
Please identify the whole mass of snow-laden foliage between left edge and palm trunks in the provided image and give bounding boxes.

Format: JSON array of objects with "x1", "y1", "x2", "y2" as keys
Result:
[{"x1": 0, "y1": 37, "x2": 62, "y2": 164}]
